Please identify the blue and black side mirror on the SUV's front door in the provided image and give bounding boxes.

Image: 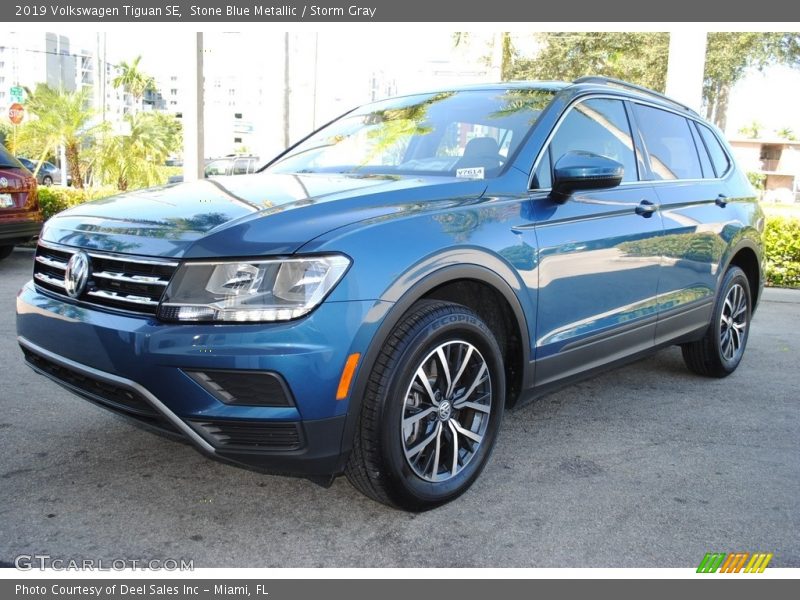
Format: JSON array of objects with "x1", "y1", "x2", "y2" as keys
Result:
[{"x1": 550, "y1": 152, "x2": 625, "y2": 204}]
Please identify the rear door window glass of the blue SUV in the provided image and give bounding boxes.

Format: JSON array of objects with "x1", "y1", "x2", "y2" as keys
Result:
[{"x1": 635, "y1": 104, "x2": 703, "y2": 179}]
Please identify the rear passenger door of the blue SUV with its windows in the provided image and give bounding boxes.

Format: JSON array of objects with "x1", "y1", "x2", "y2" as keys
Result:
[{"x1": 634, "y1": 104, "x2": 731, "y2": 343}]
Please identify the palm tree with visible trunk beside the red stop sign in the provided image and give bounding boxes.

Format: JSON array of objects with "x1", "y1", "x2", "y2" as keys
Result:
[{"x1": 15, "y1": 83, "x2": 94, "y2": 188}]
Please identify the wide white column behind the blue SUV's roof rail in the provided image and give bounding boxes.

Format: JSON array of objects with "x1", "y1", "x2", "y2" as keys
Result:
[{"x1": 666, "y1": 29, "x2": 707, "y2": 112}]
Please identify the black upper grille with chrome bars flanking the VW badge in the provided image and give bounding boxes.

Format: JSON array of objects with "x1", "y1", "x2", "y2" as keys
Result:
[{"x1": 33, "y1": 242, "x2": 178, "y2": 315}]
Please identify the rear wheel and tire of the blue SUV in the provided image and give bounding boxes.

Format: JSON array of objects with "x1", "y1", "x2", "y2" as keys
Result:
[{"x1": 681, "y1": 267, "x2": 752, "y2": 377}]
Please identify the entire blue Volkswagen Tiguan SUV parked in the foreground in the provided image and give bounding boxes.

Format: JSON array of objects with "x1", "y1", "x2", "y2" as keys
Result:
[{"x1": 17, "y1": 77, "x2": 763, "y2": 510}]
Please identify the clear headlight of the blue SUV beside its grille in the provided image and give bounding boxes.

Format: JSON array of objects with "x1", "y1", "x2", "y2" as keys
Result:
[{"x1": 158, "y1": 255, "x2": 350, "y2": 322}]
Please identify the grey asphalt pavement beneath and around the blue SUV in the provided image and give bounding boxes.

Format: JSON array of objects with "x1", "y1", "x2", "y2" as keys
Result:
[{"x1": 0, "y1": 250, "x2": 800, "y2": 567}]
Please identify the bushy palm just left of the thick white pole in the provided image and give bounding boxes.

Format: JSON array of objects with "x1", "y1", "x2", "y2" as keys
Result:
[{"x1": 94, "y1": 112, "x2": 183, "y2": 190}]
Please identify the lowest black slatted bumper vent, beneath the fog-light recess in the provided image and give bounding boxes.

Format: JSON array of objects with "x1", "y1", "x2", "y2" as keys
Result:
[{"x1": 189, "y1": 419, "x2": 302, "y2": 450}]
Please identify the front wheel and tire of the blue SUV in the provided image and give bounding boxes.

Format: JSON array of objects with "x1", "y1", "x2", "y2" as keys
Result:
[{"x1": 346, "y1": 301, "x2": 505, "y2": 511}]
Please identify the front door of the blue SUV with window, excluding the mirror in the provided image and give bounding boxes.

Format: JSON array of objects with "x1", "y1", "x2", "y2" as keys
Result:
[{"x1": 531, "y1": 98, "x2": 663, "y2": 385}]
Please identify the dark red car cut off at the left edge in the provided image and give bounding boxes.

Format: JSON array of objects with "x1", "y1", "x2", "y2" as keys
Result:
[{"x1": 0, "y1": 144, "x2": 42, "y2": 260}]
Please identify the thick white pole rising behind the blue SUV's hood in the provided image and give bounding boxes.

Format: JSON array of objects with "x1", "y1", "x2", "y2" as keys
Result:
[{"x1": 183, "y1": 32, "x2": 205, "y2": 181}]
